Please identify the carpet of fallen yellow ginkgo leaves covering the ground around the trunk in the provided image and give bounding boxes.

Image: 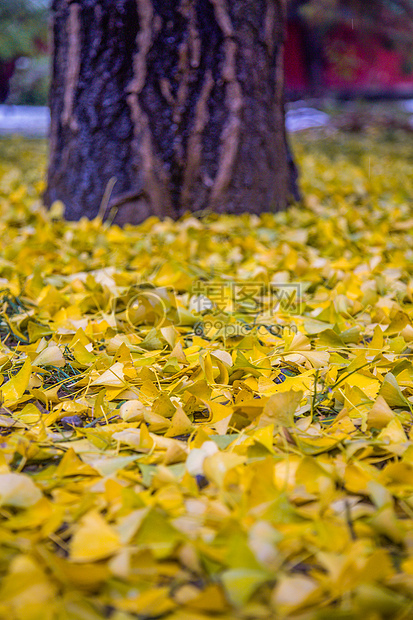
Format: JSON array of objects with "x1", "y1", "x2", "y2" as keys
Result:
[{"x1": 0, "y1": 134, "x2": 413, "y2": 620}]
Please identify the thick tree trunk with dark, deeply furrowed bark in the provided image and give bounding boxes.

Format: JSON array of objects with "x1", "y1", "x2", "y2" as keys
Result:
[{"x1": 45, "y1": 0, "x2": 291, "y2": 224}]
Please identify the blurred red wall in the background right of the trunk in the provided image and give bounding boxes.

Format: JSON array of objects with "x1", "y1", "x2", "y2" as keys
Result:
[{"x1": 285, "y1": 2, "x2": 413, "y2": 99}]
